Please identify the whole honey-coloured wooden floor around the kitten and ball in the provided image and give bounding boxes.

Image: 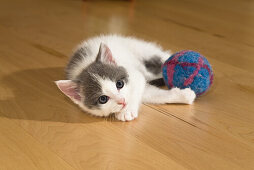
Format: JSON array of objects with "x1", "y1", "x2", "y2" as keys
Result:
[{"x1": 0, "y1": 0, "x2": 254, "y2": 170}]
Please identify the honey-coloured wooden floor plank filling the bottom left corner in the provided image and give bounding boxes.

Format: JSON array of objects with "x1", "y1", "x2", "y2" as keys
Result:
[{"x1": 0, "y1": 117, "x2": 73, "y2": 170}]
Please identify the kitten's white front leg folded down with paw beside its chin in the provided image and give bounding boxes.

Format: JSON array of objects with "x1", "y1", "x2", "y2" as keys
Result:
[{"x1": 115, "y1": 72, "x2": 146, "y2": 121}]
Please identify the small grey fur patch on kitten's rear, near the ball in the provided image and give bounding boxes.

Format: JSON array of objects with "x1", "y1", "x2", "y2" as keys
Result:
[{"x1": 144, "y1": 56, "x2": 163, "y2": 75}]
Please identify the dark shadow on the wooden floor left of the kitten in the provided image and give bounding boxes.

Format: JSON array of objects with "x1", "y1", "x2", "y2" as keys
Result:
[{"x1": 0, "y1": 67, "x2": 115, "y2": 123}]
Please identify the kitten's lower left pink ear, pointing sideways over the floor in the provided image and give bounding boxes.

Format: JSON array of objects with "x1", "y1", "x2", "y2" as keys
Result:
[{"x1": 55, "y1": 80, "x2": 81, "y2": 104}]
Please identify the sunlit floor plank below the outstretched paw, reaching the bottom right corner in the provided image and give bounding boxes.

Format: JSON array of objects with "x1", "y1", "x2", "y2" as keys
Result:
[{"x1": 111, "y1": 106, "x2": 254, "y2": 169}]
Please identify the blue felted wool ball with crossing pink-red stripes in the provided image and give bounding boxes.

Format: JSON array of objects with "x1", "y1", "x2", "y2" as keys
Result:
[{"x1": 162, "y1": 50, "x2": 213, "y2": 96}]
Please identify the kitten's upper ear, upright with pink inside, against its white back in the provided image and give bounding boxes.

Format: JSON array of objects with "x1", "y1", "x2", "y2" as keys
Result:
[{"x1": 96, "y1": 43, "x2": 116, "y2": 64}]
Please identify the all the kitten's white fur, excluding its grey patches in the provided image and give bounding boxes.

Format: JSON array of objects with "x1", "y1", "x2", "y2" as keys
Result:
[{"x1": 57, "y1": 35, "x2": 196, "y2": 121}]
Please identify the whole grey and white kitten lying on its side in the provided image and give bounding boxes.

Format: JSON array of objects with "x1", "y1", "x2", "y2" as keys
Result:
[{"x1": 56, "y1": 35, "x2": 196, "y2": 121}]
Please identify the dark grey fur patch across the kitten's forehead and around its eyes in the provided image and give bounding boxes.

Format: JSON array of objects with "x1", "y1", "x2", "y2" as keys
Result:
[{"x1": 77, "y1": 62, "x2": 128, "y2": 109}]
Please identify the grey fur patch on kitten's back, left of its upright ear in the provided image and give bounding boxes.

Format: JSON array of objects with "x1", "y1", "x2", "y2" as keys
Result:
[{"x1": 65, "y1": 47, "x2": 88, "y2": 78}]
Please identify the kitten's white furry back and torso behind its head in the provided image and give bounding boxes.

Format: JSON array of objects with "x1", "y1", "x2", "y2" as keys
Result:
[{"x1": 67, "y1": 35, "x2": 170, "y2": 81}]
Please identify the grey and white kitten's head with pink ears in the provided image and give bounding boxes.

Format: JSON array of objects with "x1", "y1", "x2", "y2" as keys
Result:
[{"x1": 56, "y1": 44, "x2": 129, "y2": 116}]
